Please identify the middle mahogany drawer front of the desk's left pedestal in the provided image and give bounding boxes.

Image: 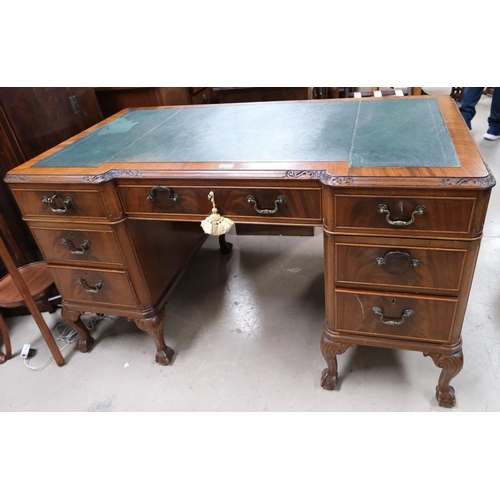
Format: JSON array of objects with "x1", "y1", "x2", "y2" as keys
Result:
[{"x1": 31, "y1": 226, "x2": 123, "y2": 264}]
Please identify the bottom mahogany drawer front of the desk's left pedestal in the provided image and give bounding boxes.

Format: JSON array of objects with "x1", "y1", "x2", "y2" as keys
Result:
[{"x1": 49, "y1": 266, "x2": 137, "y2": 307}]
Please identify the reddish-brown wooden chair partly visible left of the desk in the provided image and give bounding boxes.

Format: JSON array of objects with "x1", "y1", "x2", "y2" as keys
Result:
[{"x1": 0, "y1": 209, "x2": 64, "y2": 366}]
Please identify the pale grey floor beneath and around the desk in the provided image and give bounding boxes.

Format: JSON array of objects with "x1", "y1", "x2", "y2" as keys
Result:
[{"x1": 0, "y1": 87, "x2": 500, "y2": 412}]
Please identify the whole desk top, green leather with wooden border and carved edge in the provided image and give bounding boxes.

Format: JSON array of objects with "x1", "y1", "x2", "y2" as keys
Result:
[{"x1": 5, "y1": 96, "x2": 494, "y2": 187}]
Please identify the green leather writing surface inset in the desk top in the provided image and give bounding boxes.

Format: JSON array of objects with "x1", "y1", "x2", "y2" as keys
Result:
[{"x1": 35, "y1": 99, "x2": 460, "y2": 167}]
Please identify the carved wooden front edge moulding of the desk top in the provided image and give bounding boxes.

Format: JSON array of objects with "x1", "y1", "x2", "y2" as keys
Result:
[{"x1": 4, "y1": 169, "x2": 496, "y2": 190}]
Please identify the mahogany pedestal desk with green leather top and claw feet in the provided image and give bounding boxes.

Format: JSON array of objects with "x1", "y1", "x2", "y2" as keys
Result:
[{"x1": 5, "y1": 96, "x2": 495, "y2": 407}]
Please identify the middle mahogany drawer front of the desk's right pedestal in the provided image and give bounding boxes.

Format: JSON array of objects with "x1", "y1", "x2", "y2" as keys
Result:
[{"x1": 335, "y1": 243, "x2": 467, "y2": 293}]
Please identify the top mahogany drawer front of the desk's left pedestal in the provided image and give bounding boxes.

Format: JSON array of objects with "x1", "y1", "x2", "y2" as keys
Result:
[{"x1": 12, "y1": 187, "x2": 106, "y2": 218}]
